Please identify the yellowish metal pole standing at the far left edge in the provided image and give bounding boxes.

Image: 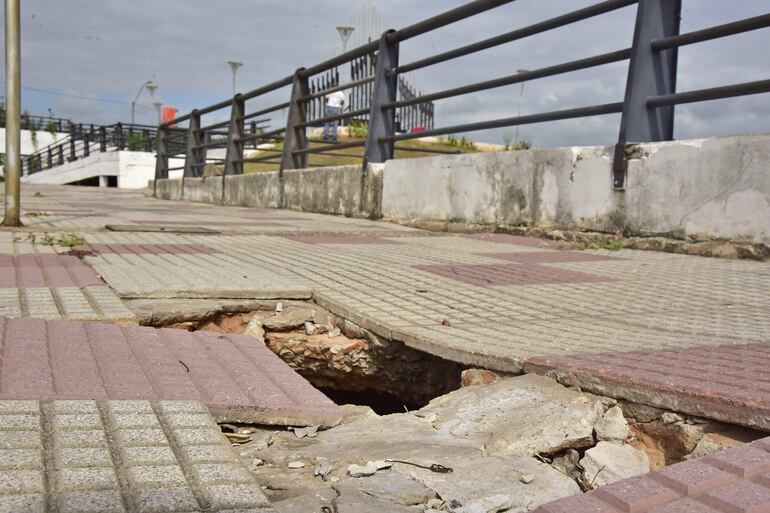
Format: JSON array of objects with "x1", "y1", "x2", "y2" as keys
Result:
[{"x1": 3, "y1": 0, "x2": 21, "y2": 226}]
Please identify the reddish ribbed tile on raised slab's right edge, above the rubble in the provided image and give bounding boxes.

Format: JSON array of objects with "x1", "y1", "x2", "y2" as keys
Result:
[{"x1": 525, "y1": 344, "x2": 770, "y2": 430}]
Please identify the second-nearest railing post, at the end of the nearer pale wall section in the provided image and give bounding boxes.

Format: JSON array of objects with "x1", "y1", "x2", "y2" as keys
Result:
[{"x1": 364, "y1": 30, "x2": 398, "y2": 165}]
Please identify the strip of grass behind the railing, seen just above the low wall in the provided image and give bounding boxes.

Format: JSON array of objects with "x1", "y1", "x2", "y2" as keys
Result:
[{"x1": 243, "y1": 137, "x2": 478, "y2": 174}]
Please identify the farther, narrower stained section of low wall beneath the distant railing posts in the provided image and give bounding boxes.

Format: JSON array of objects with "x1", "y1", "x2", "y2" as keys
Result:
[{"x1": 155, "y1": 165, "x2": 383, "y2": 217}]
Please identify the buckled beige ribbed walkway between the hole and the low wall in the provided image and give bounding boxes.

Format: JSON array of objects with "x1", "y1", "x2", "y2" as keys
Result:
[{"x1": 0, "y1": 187, "x2": 770, "y2": 428}]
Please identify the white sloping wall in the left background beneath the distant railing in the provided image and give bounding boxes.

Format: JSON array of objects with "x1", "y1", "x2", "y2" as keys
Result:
[{"x1": 22, "y1": 151, "x2": 155, "y2": 189}]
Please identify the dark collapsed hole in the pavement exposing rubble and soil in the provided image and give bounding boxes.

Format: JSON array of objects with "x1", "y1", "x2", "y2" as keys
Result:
[{"x1": 144, "y1": 302, "x2": 464, "y2": 415}]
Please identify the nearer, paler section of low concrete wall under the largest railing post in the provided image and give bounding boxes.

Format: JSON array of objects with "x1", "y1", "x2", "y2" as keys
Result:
[{"x1": 382, "y1": 134, "x2": 770, "y2": 242}]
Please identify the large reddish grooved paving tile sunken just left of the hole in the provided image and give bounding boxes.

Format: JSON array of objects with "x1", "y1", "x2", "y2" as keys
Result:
[{"x1": 0, "y1": 317, "x2": 340, "y2": 425}]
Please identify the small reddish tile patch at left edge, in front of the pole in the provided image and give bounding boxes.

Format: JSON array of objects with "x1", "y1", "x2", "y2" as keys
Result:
[{"x1": 0, "y1": 253, "x2": 104, "y2": 288}]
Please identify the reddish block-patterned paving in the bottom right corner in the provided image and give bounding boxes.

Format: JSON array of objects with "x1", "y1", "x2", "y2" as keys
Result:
[{"x1": 535, "y1": 438, "x2": 770, "y2": 513}]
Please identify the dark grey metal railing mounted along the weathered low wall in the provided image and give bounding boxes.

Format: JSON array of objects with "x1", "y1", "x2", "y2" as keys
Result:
[{"x1": 156, "y1": 0, "x2": 770, "y2": 189}]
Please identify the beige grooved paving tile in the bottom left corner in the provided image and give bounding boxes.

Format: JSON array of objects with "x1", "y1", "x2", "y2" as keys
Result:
[{"x1": 0, "y1": 400, "x2": 273, "y2": 513}]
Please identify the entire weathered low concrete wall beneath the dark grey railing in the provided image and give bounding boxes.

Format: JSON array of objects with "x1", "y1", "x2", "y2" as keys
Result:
[{"x1": 157, "y1": 134, "x2": 770, "y2": 243}]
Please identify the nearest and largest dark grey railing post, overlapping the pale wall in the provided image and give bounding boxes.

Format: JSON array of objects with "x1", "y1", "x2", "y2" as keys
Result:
[{"x1": 612, "y1": 0, "x2": 682, "y2": 189}]
